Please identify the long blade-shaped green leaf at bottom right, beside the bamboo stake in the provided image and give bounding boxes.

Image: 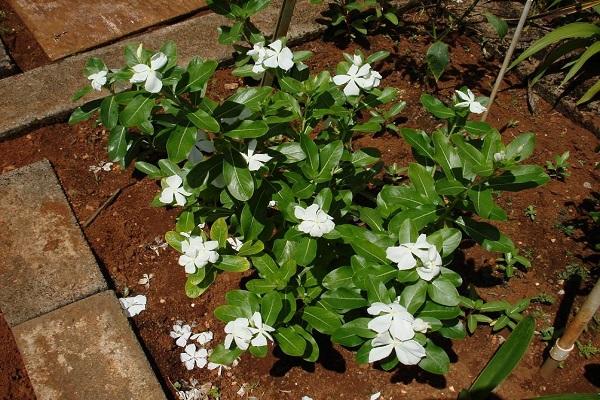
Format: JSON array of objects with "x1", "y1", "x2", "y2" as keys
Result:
[{"x1": 469, "y1": 317, "x2": 535, "y2": 400}]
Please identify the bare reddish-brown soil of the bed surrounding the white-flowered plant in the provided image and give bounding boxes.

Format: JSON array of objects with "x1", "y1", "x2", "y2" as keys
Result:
[{"x1": 0, "y1": 32, "x2": 600, "y2": 400}]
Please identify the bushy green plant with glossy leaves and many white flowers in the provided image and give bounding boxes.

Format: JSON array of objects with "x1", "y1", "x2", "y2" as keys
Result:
[{"x1": 71, "y1": 40, "x2": 548, "y2": 373}]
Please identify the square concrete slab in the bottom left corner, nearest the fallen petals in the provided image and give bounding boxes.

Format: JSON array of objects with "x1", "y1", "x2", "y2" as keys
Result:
[{"x1": 13, "y1": 291, "x2": 166, "y2": 400}]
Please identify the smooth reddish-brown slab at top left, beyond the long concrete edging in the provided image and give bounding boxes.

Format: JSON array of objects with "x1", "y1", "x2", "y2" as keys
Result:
[{"x1": 8, "y1": 0, "x2": 206, "y2": 60}]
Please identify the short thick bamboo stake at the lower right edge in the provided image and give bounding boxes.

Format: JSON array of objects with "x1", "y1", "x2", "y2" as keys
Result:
[{"x1": 540, "y1": 279, "x2": 600, "y2": 378}]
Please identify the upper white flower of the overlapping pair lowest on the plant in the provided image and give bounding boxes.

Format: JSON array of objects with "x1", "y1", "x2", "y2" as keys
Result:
[{"x1": 367, "y1": 302, "x2": 415, "y2": 340}]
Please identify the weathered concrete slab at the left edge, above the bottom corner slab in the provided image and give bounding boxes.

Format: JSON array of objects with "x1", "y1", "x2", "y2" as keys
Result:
[{"x1": 0, "y1": 160, "x2": 106, "y2": 326}]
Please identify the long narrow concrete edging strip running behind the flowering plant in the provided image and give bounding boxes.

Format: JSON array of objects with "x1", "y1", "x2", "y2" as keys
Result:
[{"x1": 0, "y1": 0, "x2": 325, "y2": 139}]
